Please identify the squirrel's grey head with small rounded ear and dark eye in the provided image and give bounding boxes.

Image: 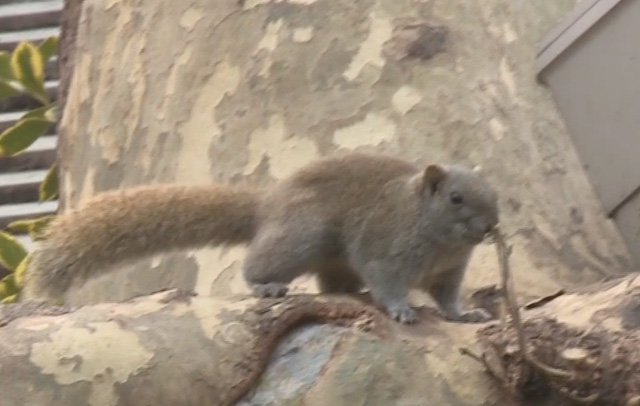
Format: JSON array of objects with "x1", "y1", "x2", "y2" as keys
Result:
[{"x1": 418, "y1": 165, "x2": 498, "y2": 244}]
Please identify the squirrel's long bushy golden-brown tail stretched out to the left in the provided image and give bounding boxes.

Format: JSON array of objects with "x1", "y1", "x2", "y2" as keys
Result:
[{"x1": 23, "y1": 186, "x2": 259, "y2": 300}]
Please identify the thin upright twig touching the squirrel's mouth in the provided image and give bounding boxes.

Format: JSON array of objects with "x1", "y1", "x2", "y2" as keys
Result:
[{"x1": 493, "y1": 227, "x2": 573, "y2": 378}]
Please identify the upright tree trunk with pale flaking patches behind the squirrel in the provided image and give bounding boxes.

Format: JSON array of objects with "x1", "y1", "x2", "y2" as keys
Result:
[{"x1": 61, "y1": 0, "x2": 630, "y2": 303}]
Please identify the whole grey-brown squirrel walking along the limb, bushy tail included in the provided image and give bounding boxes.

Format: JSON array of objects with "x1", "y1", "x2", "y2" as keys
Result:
[{"x1": 23, "y1": 152, "x2": 498, "y2": 324}]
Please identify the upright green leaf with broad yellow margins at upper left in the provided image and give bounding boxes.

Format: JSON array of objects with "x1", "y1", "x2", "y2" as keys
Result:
[{"x1": 11, "y1": 41, "x2": 49, "y2": 104}]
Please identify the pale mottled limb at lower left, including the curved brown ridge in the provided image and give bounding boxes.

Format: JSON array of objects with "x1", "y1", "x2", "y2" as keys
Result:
[{"x1": 0, "y1": 291, "x2": 388, "y2": 406}]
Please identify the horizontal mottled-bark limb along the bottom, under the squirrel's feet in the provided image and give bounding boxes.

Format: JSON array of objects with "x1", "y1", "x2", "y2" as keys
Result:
[{"x1": 5, "y1": 278, "x2": 640, "y2": 406}]
